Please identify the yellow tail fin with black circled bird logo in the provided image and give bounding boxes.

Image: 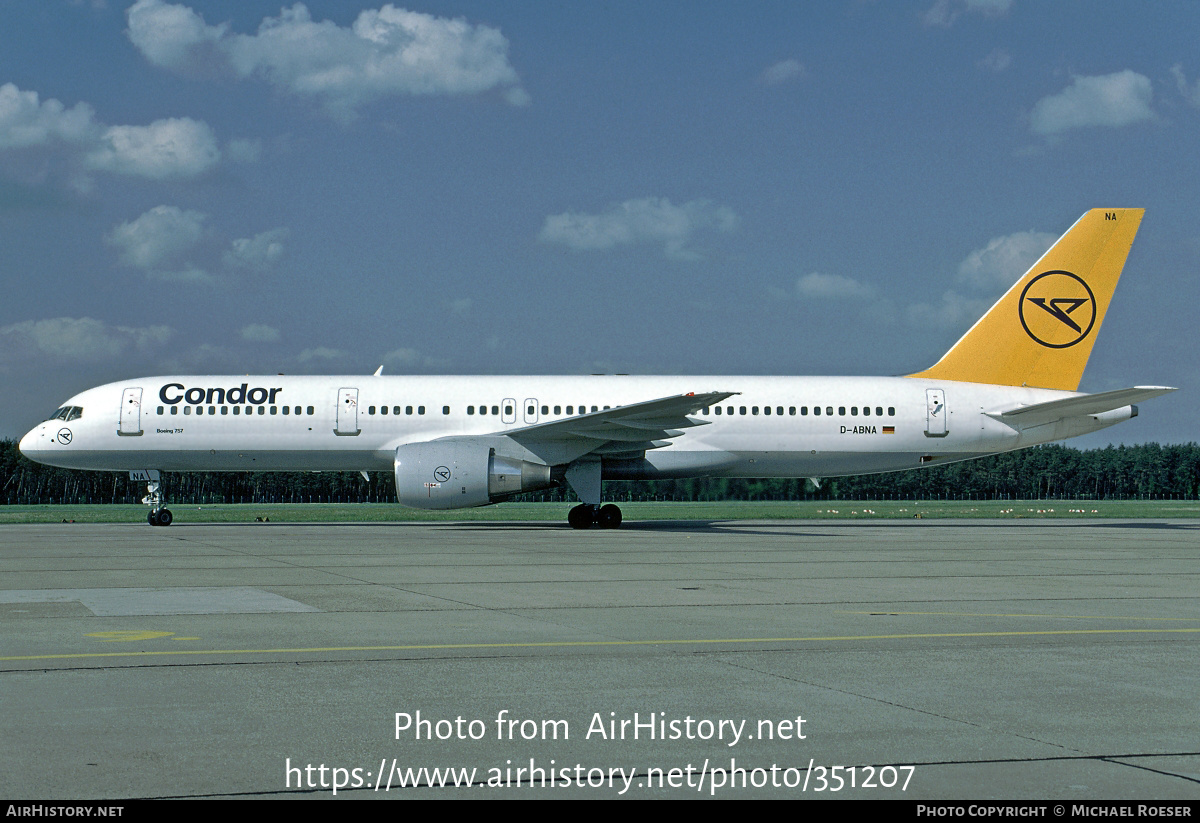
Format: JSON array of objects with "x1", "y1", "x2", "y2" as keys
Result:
[{"x1": 908, "y1": 209, "x2": 1145, "y2": 391}]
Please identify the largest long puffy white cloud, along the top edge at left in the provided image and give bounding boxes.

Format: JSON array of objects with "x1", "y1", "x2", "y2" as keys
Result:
[{"x1": 126, "y1": 0, "x2": 529, "y2": 118}]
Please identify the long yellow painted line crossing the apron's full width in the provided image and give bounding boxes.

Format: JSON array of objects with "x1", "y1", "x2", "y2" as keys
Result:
[{"x1": 0, "y1": 629, "x2": 1200, "y2": 661}]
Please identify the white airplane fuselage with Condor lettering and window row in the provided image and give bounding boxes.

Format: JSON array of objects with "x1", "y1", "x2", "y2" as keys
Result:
[{"x1": 20, "y1": 376, "x2": 1130, "y2": 480}]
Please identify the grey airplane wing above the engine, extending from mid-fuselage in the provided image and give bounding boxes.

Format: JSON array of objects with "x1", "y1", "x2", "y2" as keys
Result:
[{"x1": 504, "y1": 391, "x2": 738, "y2": 465}]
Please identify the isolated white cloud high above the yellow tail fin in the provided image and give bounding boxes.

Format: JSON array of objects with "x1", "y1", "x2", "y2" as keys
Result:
[{"x1": 1030, "y1": 68, "x2": 1154, "y2": 134}]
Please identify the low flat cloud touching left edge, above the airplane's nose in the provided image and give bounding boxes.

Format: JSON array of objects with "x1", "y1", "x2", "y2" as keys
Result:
[{"x1": 0, "y1": 317, "x2": 173, "y2": 364}]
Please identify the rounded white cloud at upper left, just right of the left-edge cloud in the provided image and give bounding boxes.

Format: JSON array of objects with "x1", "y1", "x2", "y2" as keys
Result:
[{"x1": 84, "y1": 118, "x2": 221, "y2": 180}]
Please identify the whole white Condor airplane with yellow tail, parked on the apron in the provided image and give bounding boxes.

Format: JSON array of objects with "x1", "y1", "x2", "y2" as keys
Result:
[{"x1": 19, "y1": 209, "x2": 1175, "y2": 529}]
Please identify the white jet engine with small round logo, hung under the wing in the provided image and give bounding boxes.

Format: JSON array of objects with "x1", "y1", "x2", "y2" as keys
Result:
[{"x1": 395, "y1": 437, "x2": 554, "y2": 509}]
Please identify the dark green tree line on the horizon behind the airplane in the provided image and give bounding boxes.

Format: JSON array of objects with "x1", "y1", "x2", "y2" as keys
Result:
[{"x1": 0, "y1": 440, "x2": 1200, "y2": 505}]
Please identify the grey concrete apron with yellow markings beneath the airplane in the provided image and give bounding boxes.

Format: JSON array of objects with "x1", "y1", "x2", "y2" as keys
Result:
[{"x1": 0, "y1": 515, "x2": 1200, "y2": 803}]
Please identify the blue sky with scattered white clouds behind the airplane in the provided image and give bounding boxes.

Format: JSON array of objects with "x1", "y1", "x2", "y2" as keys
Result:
[{"x1": 0, "y1": 0, "x2": 1200, "y2": 446}]
